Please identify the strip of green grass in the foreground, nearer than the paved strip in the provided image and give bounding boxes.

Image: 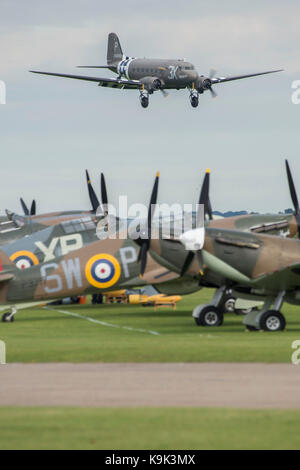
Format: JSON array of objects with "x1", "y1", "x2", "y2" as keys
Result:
[{"x1": 0, "y1": 407, "x2": 300, "y2": 454}]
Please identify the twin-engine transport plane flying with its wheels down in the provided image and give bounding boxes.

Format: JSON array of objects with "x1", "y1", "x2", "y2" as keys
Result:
[{"x1": 31, "y1": 33, "x2": 281, "y2": 108}]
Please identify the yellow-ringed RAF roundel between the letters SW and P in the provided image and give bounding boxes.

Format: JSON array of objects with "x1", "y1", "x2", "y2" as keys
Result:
[{"x1": 85, "y1": 253, "x2": 121, "y2": 289}]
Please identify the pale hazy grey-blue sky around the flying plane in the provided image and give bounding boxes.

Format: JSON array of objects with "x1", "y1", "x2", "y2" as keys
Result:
[{"x1": 0, "y1": 0, "x2": 300, "y2": 212}]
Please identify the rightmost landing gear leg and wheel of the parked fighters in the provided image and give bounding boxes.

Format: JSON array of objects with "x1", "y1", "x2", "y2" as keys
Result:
[{"x1": 243, "y1": 291, "x2": 286, "y2": 331}]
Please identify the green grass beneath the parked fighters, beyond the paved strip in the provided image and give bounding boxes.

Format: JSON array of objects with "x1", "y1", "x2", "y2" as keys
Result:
[{"x1": 0, "y1": 289, "x2": 300, "y2": 363}]
